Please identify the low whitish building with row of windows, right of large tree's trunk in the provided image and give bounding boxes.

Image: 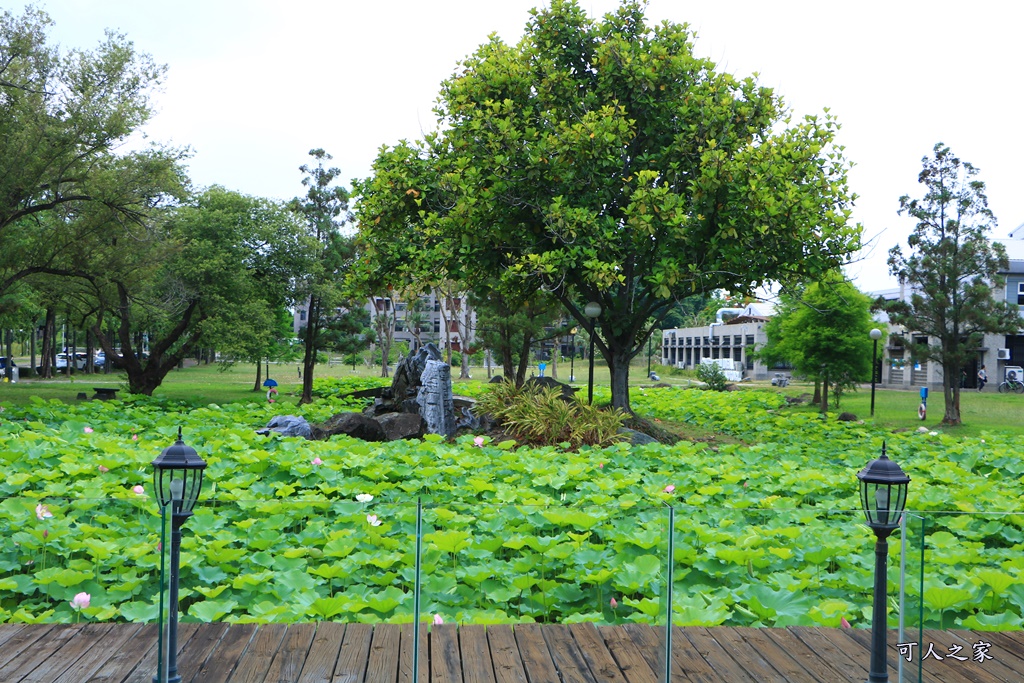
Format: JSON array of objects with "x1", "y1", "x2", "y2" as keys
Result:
[{"x1": 662, "y1": 304, "x2": 771, "y2": 380}]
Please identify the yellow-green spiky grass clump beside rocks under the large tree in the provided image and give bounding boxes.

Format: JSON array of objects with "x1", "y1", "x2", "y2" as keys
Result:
[{"x1": 477, "y1": 382, "x2": 626, "y2": 449}]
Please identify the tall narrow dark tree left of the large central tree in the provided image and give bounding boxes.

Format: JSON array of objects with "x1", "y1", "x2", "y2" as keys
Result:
[{"x1": 292, "y1": 148, "x2": 354, "y2": 403}]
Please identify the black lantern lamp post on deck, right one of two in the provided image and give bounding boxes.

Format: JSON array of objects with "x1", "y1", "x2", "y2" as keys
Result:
[{"x1": 857, "y1": 443, "x2": 910, "y2": 683}]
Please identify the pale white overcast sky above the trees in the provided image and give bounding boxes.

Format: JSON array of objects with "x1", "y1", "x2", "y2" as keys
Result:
[{"x1": 36, "y1": 0, "x2": 1024, "y2": 291}]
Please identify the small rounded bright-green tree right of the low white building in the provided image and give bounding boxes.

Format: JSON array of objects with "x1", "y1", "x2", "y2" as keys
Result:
[{"x1": 758, "y1": 272, "x2": 874, "y2": 413}]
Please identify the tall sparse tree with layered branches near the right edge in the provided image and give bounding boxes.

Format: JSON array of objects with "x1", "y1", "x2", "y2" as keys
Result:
[{"x1": 880, "y1": 142, "x2": 1021, "y2": 425}]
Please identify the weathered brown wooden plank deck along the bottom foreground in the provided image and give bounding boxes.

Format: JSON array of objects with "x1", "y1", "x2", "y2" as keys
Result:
[{"x1": 0, "y1": 623, "x2": 1024, "y2": 683}]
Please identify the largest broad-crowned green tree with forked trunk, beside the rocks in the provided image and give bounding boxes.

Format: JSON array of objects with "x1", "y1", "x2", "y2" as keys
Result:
[{"x1": 359, "y1": 0, "x2": 860, "y2": 410}]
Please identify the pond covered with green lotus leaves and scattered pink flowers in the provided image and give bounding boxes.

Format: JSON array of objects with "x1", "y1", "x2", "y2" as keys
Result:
[{"x1": 0, "y1": 385, "x2": 1024, "y2": 629}]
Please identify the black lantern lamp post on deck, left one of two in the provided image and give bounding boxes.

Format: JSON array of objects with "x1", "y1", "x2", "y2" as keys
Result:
[{"x1": 153, "y1": 427, "x2": 206, "y2": 683}]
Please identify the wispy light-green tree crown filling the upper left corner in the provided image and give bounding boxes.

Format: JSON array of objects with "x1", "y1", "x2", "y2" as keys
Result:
[{"x1": 0, "y1": 7, "x2": 169, "y2": 294}]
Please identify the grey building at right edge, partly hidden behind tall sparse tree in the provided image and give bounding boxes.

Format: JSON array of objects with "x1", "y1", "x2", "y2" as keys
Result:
[{"x1": 873, "y1": 225, "x2": 1024, "y2": 388}]
